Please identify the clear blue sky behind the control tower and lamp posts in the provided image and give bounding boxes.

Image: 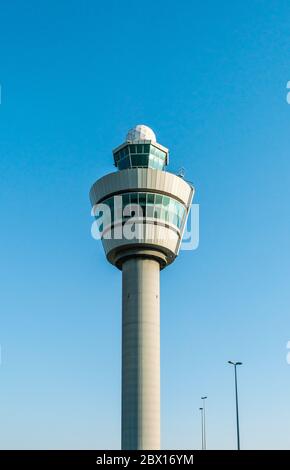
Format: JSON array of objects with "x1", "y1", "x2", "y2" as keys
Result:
[{"x1": 0, "y1": 0, "x2": 290, "y2": 449}]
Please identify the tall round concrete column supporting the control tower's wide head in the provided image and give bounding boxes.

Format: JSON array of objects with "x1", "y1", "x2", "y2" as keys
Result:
[{"x1": 122, "y1": 257, "x2": 160, "y2": 450}]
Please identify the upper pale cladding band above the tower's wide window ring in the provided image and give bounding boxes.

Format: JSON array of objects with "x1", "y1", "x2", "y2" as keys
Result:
[{"x1": 90, "y1": 168, "x2": 194, "y2": 209}]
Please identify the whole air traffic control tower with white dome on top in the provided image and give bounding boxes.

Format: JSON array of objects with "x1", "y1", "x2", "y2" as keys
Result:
[{"x1": 90, "y1": 125, "x2": 194, "y2": 450}]
